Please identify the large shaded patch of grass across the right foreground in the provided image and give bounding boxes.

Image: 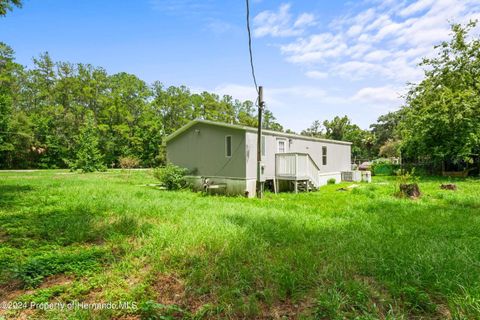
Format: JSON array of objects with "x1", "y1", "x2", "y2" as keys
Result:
[{"x1": 175, "y1": 199, "x2": 480, "y2": 318}]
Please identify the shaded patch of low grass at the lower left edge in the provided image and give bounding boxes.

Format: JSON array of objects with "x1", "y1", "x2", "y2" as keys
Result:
[{"x1": 0, "y1": 207, "x2": 145, "y2": 288}]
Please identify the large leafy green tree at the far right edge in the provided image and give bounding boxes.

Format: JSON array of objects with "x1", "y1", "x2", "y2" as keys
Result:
[{"x1": 400, "y1": 22, "x2": 480, "y2": 168}]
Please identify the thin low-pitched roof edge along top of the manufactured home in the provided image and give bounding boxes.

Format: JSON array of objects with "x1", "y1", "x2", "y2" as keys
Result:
[{"x1": 165, "y1": 119, "x2": 352, "y2": 145}]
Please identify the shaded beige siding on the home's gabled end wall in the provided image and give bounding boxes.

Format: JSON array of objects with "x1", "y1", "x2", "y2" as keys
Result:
[{"x1": 167, "y1": 123, "x2": 246, "y2": 178}]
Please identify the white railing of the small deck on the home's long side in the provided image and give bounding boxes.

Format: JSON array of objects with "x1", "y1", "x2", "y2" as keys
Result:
[{"x1": 275, "y1": 153, "x2": 320, "y2": 187}]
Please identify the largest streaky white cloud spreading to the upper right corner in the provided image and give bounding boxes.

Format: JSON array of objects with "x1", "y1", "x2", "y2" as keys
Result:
[{"x1": 274, "y1": 0, "x2": 480, "y2": 84}]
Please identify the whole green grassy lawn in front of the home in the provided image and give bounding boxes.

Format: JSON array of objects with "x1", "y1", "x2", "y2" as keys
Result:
[{"x1": 0, "y1": 171, "x2": 480, "y2": 319}]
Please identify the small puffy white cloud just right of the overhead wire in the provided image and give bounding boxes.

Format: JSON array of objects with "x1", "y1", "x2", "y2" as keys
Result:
[{"x1": 253, "y1": 3, "x2": 315, "y2": 37}]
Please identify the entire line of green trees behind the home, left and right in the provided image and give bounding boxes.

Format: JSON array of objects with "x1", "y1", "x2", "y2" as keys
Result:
[{"x1": 0, "y1": 0, "x2": 480, "y2": 170}]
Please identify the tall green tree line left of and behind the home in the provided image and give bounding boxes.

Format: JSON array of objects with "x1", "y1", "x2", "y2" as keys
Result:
[{"x1": 0, "y1": 47, "x2": 283, "y2": 168}]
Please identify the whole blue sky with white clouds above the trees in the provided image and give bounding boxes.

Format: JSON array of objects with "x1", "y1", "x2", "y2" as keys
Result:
[{"x1": 0, "y1": 0, "x2": 480, "y2": 131}]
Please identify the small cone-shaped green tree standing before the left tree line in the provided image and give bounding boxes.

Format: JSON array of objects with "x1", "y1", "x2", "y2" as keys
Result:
[{"x1": 71, "y1": 112, "x2": 105, "y2": 172}]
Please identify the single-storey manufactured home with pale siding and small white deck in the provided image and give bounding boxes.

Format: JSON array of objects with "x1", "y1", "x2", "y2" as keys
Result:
[{"x1": 166, "y1": 120, "x2": 351, "y2": 197}]
